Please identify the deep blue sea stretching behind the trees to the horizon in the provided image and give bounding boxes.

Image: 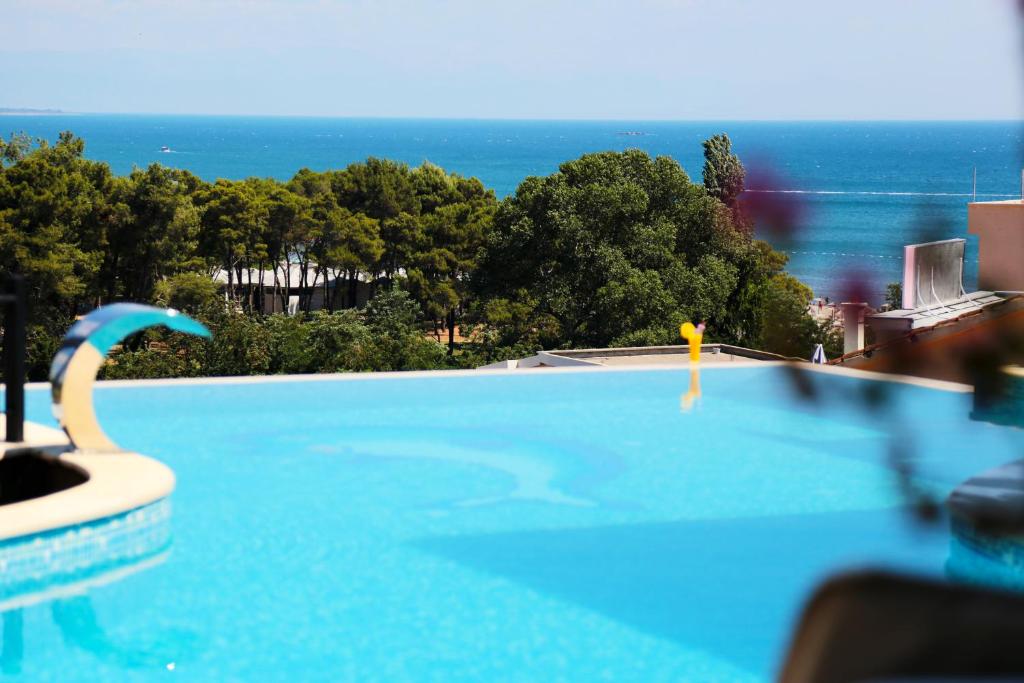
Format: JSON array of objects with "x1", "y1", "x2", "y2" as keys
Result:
[{"x1": 0, "y1": 114, "x2": 1024, "y2": 304}]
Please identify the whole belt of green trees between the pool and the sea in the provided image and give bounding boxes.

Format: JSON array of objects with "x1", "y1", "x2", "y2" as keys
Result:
[{"x1": 0, "y1": 133, "x2": 835, "y2": 379}]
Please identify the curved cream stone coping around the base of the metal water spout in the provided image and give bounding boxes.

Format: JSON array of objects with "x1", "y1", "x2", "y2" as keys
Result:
[{"x1": 0, "y1": 422, "x2": 175, "y2": 542}]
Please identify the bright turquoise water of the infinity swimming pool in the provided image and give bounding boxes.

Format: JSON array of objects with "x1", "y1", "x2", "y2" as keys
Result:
[{"x1": 3, "y1": 366, "x2": 1021, "y2": 682}]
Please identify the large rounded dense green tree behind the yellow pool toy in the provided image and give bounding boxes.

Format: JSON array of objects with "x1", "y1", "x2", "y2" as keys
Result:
[{"x1": 472, "y1": 150, "x2": 812, "y2": 356}]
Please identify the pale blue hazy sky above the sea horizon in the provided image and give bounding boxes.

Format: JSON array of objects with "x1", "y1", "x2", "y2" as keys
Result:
[{"x1": 0, "y1": 0, "x2": 1024, "y2": 120}]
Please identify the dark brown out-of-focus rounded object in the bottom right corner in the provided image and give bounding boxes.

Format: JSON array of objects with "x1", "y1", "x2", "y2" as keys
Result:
[{"x1": 779, "y1": 571, "x2": 1024, "y2": 683}]
